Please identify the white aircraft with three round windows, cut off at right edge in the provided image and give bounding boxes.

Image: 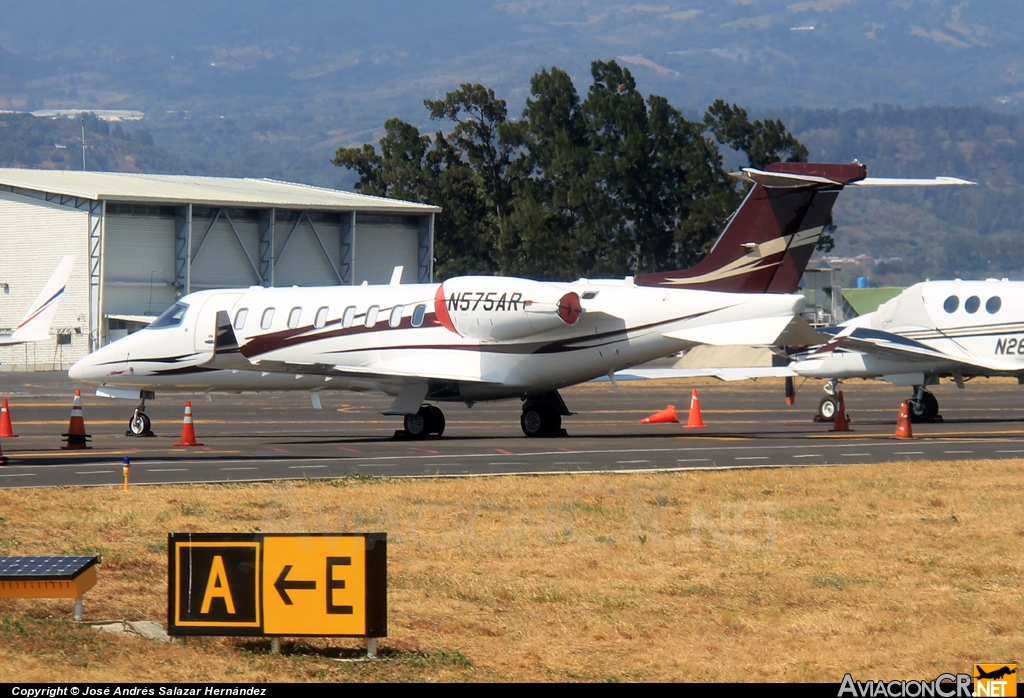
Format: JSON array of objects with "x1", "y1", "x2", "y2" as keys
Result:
[{"x1": 776, "y1": 279, "x2": 1024, "y2": 422}]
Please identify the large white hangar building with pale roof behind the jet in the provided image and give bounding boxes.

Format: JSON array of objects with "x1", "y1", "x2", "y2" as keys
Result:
[{"x1": 0, "y1": 168, "x2": 440, "y2": 370}]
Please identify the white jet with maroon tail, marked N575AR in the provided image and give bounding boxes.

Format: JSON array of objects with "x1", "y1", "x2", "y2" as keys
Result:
[{"x1": 69, "y1": 163, "x2": 913, "y2": 437}]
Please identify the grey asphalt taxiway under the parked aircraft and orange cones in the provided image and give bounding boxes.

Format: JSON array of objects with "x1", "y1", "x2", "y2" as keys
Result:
[{"x1": 0, "y1": 372, "x2": 1024, "y2": 487}]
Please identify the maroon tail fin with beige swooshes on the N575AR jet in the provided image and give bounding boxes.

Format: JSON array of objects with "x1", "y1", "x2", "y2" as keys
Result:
[{"x1": 634, "y1": 163, "x2": 867, "y2": 293}]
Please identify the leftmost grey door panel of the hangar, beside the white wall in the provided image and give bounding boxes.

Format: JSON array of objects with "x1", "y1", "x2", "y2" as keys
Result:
[{"x1": 103, "y1": 204, "x2": 174, "y2": 316}]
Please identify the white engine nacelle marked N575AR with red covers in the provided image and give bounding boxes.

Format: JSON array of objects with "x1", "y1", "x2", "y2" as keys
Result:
[{"x1": 434, "y1": 276, "x2": 583, "y2": 341}]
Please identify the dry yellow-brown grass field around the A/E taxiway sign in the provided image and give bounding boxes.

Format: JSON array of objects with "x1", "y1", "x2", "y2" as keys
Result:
[{"x1": 0, "y1": 461, "x2": 1024, "y2": 682}]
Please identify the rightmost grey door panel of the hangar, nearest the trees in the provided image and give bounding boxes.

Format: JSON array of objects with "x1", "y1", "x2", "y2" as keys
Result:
[{"x1": 352, "y1": 213, "x2": 420, "y2": 283}]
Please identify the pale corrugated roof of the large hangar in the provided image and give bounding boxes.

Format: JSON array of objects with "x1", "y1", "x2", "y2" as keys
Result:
[{"x1": 0, "y1": 168, "x2": 440, "y2": 214}]
